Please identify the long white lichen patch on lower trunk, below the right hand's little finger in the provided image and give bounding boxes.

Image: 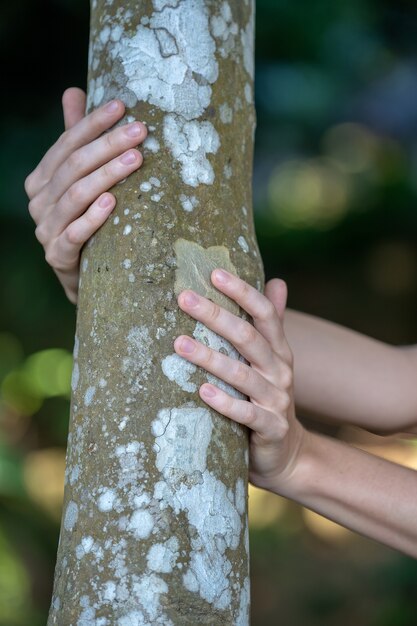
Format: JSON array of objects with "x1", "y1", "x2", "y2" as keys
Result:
[{"x1": 152, "y1": 406, "x2": 242, "y2": 609}]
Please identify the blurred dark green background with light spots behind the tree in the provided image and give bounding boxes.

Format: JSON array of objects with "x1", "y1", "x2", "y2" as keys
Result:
[{"x1": 0, "y1": 0, "x2": 417, "y2": 626}]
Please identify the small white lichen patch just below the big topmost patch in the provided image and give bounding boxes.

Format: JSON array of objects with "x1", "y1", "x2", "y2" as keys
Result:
[{"x1": 163, "y1": 115, "x2": 220, "y2": 187}]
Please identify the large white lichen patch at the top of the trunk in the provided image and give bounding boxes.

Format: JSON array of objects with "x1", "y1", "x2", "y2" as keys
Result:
[{"x1": 112, "y1": 2, "x2": 218, "y2": 119}]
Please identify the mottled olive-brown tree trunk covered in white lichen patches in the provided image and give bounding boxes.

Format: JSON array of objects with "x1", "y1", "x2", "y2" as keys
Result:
[{"x1": 48, "y1": 0, "x2": 263, "y2": 626}]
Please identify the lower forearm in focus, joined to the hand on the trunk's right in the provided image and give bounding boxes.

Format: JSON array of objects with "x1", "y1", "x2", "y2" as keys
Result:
[{"x1": 268, "y1": 433, "x2": 417, "y2": 558}]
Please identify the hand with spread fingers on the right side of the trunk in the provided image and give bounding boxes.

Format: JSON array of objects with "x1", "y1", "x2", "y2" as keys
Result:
[{"x1": 174, "y1": 269, "x2": 306, "y2": 493}]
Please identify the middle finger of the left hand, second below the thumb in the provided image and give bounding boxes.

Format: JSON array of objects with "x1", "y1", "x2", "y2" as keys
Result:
[{"x1": 45, "y1": 122, "x2": 147, "y2": 203}]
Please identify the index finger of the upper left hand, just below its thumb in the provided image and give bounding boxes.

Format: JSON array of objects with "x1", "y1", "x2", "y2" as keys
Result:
[{"x1": 28, "y1": 100, "x2": 125, "y2": 196}]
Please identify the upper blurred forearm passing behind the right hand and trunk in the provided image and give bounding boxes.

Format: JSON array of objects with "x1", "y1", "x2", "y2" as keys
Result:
[{"x1": 284, "y1": 310, "x2": 417, "y2": 433}]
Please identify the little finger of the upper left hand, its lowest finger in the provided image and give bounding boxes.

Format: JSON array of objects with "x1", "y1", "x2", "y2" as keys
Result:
[{"x1": 46, "y1": 193, "x2": 116, "y2": 271}]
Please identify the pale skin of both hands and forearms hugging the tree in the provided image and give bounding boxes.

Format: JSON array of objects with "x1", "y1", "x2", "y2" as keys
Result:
[{"x1": 25, "y1": 88, "x2": 417, "y2": 558}]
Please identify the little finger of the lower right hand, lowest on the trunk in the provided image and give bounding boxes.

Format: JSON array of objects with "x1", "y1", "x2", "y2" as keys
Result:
[{"x1": 199, "y1": 383, "x2": 284, "y2": 440}]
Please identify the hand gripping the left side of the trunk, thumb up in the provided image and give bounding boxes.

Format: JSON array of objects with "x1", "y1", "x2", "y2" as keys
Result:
[{"x1": 25, "y1": 87, "x2": 147, "y2": 304}]
